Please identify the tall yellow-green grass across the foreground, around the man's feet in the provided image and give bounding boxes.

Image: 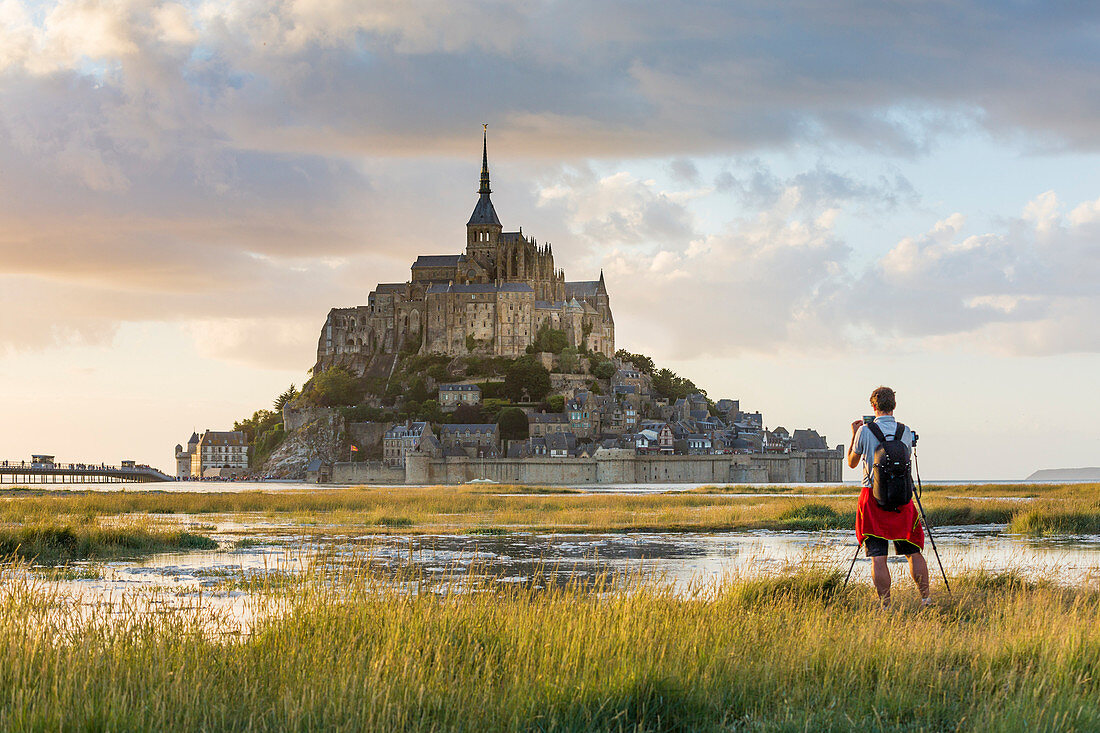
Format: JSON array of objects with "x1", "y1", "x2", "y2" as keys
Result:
[{"x1": 0, "y1": 559, "x2": 1100, "y2": 731}]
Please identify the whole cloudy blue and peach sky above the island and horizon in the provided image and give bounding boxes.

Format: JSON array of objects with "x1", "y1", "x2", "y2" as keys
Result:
[{"x1": 0, "y1": 0, "x2": 1100, "y2": 480}]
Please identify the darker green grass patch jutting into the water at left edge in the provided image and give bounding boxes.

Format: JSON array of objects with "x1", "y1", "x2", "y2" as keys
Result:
[{"x1": 0, "y1": 522, "x2": 218, "y2": 565}]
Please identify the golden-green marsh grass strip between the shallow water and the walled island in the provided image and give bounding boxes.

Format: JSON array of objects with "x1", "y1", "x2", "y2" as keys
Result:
[{"x1": 0, "y1": 484, "x2": 1100, "y2": 535}]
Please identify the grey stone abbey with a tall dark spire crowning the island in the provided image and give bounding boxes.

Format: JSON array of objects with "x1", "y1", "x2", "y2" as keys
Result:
[{"x1": 314, "y1": 131, "x2": 615, "y2": 373}]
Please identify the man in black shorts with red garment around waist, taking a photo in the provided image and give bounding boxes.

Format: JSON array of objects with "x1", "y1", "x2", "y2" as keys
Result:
[{"x1": 848, "y1": 386, "x2": 932, "y2": 608}]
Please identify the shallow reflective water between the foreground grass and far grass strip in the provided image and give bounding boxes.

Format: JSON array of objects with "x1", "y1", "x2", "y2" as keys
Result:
[{"x1": 24, "y1": 518, "x2": 1100, "y2": 628}]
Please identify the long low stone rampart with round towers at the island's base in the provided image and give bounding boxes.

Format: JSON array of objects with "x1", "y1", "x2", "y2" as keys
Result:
[{"x1": 332, "y1": 449, "x2": 843, "y2": 485}]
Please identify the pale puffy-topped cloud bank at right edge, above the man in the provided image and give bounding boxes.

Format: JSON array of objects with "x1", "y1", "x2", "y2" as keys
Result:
[{"x1": 828, "y1": 192, "x2": 1100, "y2": 354}]
